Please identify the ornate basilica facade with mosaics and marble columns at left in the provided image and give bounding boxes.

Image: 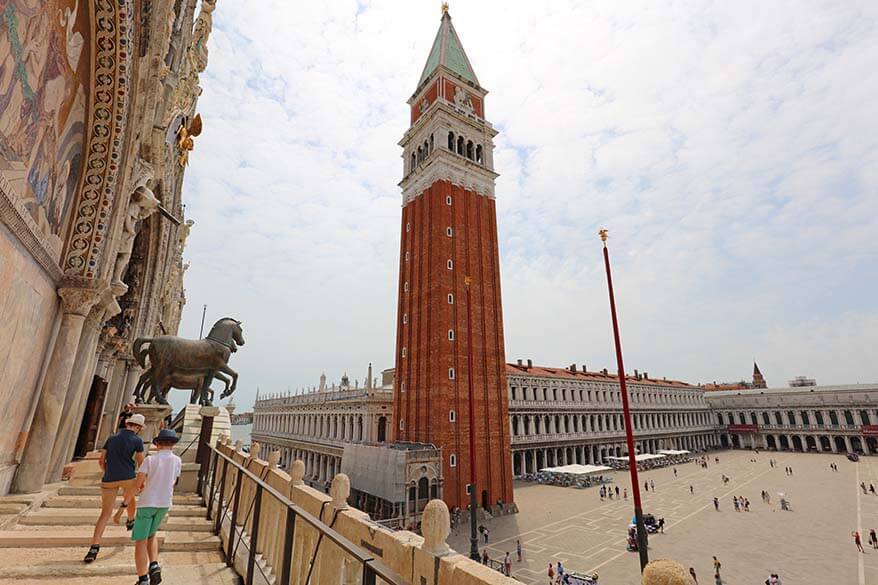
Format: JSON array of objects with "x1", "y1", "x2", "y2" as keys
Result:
[{"x1": 0, "y1": 0, "x2": 215, "y2": 494}]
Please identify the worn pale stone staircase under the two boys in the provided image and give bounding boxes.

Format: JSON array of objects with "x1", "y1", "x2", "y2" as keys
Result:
[{"x1": 0, "y1": 460, "x2": 241, "y2": 585}]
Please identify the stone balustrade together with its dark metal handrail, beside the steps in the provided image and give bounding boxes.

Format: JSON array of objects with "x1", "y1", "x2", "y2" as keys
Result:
[{"x1": 208, "y1": 441, "x2": 518, "y2": 585}]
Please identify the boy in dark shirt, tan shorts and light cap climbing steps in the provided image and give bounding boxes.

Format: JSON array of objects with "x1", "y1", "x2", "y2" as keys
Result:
[{"x1": 83, "y1": 414, "x2": 146, "y2": 563}]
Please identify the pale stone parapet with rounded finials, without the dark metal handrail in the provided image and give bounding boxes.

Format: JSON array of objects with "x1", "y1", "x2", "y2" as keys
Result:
[{"x1": 207, "y1": 440, "x2": 517, "y2": 585}]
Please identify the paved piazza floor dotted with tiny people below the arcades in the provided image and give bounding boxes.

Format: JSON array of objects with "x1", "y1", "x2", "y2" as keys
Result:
[{"x1": 449, "y1": 451, "x2": 878, "y2": 585}]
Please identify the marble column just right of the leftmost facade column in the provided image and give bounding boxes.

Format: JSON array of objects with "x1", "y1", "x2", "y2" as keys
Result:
[{"x1": 48, "y1": 299, "x2": 120, "y2": 482}]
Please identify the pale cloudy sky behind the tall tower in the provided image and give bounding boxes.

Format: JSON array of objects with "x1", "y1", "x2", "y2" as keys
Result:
[{"x1": 174, "y1": 0, "x2": 878, "y2": 406}]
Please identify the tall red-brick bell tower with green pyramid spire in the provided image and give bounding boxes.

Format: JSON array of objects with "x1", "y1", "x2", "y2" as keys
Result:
[{"x1": 394, "y1": 8, "x2": 512, "y2": 508}]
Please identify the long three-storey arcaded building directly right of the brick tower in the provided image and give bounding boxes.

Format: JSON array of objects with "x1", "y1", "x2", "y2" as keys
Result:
[{"x1": 506, "y1": 360, "x2": 719, "y2": 476}]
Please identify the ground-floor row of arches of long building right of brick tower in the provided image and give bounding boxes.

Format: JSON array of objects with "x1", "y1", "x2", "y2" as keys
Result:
[{"x1": 512, "y1": 433, "x2": 718, "y2": 476}]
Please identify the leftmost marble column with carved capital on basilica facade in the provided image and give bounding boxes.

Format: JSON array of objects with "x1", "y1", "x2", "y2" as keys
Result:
[{"x1": 12, "y1": 287, "x2": 98, "y2": 493}]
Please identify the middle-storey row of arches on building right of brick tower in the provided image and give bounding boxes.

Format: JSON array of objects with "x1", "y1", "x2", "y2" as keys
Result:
[{"x1": 510, "y1": 412, "x2": 710, "y2": 437}]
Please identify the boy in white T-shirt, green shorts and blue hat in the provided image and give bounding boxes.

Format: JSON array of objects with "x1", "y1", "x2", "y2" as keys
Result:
[{"x1": 131, "y1": 429, "x2": 183, "y2": 585}]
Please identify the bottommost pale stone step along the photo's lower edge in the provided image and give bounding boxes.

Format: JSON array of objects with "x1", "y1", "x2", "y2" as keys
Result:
[{"x1": 0, "y1": 561, "x2": 241, "y2": 585}]
